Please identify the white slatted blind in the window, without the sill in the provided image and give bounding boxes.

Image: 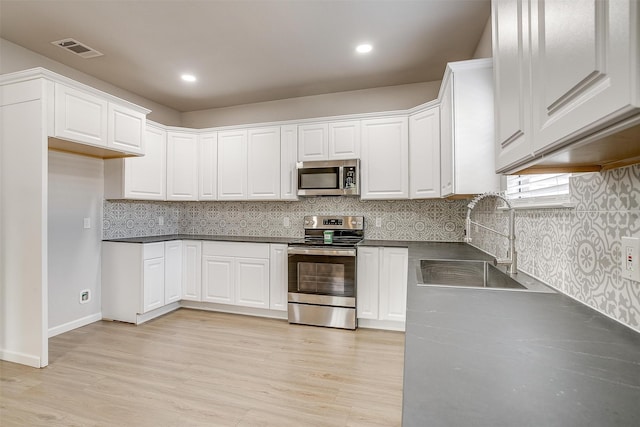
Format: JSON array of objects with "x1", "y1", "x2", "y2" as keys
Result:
[{"x1": 507, "y1": 173, "x2": 571, "y2": 199}]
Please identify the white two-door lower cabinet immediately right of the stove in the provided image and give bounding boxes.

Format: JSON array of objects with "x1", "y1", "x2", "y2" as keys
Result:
[{"x1": 357, "y1": 246, "x2": 409, "y2": 330}]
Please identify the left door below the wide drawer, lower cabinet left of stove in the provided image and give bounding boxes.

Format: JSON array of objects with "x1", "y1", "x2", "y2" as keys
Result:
[{"x1": 202, "y1": 255, "x2": 235, "y2": 304}]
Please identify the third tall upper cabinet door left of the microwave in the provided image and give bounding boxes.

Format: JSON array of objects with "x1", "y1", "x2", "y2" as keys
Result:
[{"x1": 218, "y1": 130, "x2": 247, "y2": 200}]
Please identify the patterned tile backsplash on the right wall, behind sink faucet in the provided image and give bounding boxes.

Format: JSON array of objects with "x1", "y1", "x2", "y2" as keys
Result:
[{"x1": 464, "y1": 165, "x2": 640, "y2": 332}]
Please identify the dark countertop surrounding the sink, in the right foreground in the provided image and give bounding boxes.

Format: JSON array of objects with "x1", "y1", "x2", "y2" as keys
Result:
[{"x1": 402, "y1": 243, "x2": 640, "y2": 427}]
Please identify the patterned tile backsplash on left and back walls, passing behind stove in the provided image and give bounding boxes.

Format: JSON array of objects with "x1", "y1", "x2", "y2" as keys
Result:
[{"x1": 103, "y1": 197, "x2": 466, "y2": 242}]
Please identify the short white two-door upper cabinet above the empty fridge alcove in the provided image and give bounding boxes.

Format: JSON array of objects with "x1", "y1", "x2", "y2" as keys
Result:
[{"x1": 52, "y1": 83, "x2": 146, "y2": 157}]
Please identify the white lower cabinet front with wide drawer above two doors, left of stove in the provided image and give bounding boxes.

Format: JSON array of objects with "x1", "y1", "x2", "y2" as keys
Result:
[{"x1": 202, "y1": 242, "x2": 270, "y2": 309}]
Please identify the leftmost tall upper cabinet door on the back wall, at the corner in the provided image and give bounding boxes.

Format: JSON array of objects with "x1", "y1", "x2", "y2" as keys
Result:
[{"x1": 167, "y1": 132, "x2": 198, "y2": 200}]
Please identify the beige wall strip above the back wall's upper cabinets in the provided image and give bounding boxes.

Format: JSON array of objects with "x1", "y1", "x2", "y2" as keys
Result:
[{"x1": 182, "y1": 81, "x2": 440, "y2": 129}]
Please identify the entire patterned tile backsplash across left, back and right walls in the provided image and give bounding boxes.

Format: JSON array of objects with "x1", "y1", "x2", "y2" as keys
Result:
[{"x1": 103, "y1": 165, "x2": 640, "y2": 332}]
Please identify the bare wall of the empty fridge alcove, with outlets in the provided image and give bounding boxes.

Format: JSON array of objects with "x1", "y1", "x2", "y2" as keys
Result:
[{"x1": 48, "y1": 151, "x2": 104, "y2": 336}]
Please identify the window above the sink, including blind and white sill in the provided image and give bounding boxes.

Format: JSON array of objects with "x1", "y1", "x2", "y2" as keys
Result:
[{"x1": 506, "y1": 173, "x2": 571, "y2": 207}]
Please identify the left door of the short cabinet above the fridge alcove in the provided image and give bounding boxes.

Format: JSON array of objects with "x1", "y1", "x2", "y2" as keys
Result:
[{"x1": 54, "y1": 83, "x2": 108, "y2": 147}]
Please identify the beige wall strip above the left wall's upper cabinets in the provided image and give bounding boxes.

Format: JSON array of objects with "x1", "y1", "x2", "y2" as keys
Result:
[{"x1": 0, "y1": 38, "x2": 180, "y2": 126}]
